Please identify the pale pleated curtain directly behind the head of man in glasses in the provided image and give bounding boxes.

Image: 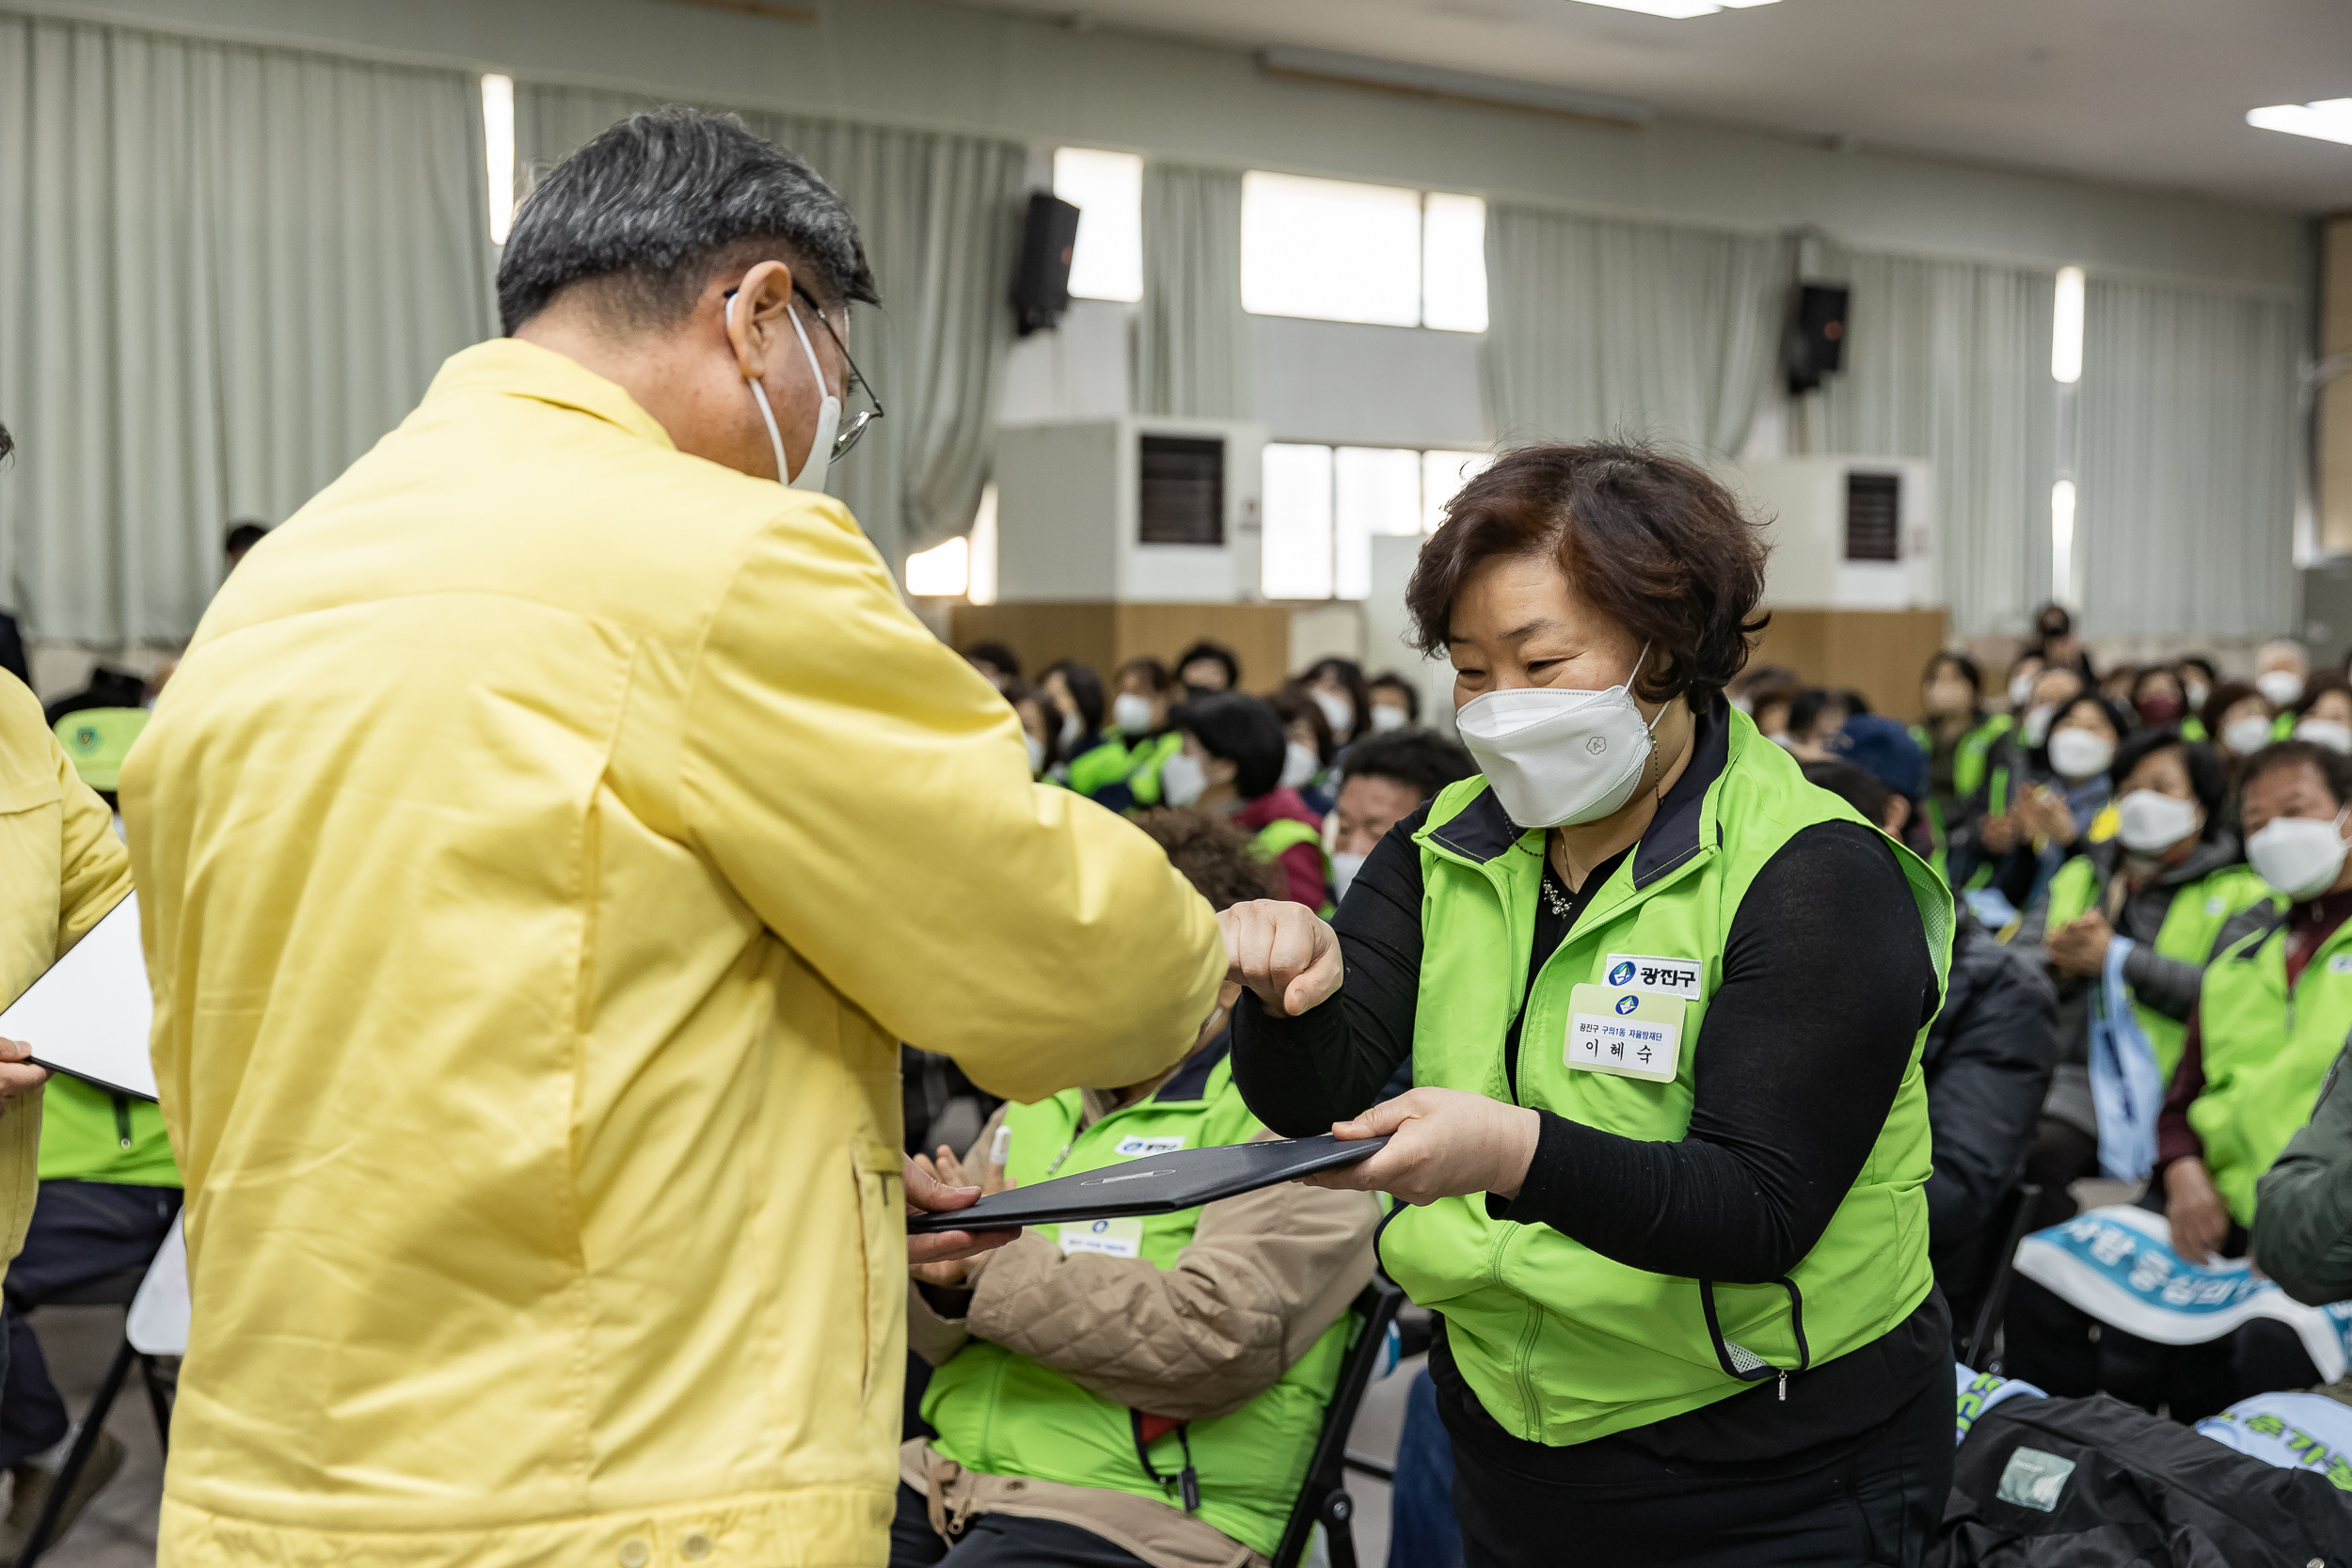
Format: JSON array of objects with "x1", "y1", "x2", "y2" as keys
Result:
[{"x1": 516, "y1": 82, "x2": 1028, "y2": 566}]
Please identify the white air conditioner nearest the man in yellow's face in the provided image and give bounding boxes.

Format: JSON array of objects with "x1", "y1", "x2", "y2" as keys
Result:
[{"x1": 997, "y1": 416, "x2": 1265, "y2": 604}]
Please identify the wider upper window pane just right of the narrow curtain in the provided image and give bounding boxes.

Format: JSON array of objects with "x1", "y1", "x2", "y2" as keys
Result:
[{"x1": 1242, "y1": 169, "x2": 1421, "y2": 326}]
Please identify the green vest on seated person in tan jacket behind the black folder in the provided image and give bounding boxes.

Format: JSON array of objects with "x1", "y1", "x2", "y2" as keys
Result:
[{"x1": 922, "y1": 1049, "x2": 1353, "y2": 1557}]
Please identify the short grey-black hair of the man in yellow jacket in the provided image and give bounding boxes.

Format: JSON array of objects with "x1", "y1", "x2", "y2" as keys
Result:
[{"x1": 499, "y1": 108, "x2": 882, "y2": 342}]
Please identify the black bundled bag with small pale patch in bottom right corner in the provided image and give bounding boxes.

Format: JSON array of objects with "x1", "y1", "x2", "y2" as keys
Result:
[{"x1": 1927, "y1": 1394, "x2": 2352, "y2": 1568}]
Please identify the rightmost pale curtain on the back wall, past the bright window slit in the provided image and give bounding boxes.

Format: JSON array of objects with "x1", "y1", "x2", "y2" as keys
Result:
[{"x1": 2074, "y1": 277, "x2": 2303, "y2": 637}]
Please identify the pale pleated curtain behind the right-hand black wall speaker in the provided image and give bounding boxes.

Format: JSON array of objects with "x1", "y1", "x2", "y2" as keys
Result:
[{"x1": 1792, "y1": 249, "x2": 2058, "y2": 637}]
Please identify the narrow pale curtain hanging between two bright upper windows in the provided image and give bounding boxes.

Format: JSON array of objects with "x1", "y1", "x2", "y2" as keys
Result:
[{"x1": 1136, "y1": 160, "x2": 1251, "y2": 419}]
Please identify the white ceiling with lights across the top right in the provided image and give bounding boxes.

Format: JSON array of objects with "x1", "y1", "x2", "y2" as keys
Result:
[{"x1": 946, "y1": 0, "x2": 2352, "y2": 212}]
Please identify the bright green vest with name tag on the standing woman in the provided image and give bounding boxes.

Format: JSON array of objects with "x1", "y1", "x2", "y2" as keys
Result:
[{"x1": 1381, "y1": 712, "x2": 1952, "y2": 1446}]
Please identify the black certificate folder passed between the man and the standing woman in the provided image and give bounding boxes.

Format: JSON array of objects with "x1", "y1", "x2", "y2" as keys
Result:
[{"x1": 906, "y1": 1133, "x2": 1388, "y2": 1237}]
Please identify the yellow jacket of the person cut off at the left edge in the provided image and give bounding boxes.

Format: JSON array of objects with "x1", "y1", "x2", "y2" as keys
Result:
[{"x1": 0, "y1": 674, "x2": 131, "y2": 1303}]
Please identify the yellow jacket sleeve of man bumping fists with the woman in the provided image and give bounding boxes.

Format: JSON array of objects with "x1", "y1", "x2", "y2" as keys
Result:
[{"x1": 682, "y1": 503, "x2": 1226, "y2": 1101}]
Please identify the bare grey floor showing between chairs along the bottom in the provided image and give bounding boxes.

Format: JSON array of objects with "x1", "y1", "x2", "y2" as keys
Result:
[{"x1": 18, "y1": 1307, "x2": 1421, "y2": 1568}]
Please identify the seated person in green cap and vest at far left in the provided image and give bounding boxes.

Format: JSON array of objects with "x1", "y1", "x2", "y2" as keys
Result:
[{"x1": 0, "y1": 707, "x2": 182, "y2": 1557}]
